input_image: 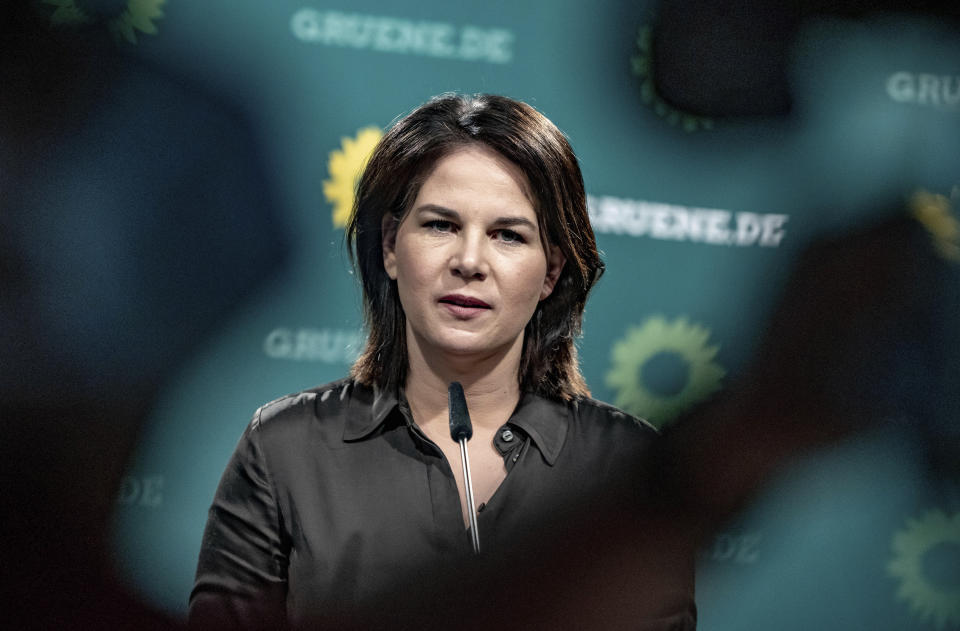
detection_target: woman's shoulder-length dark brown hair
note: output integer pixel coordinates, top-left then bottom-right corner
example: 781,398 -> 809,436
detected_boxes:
346,94 -> 603,400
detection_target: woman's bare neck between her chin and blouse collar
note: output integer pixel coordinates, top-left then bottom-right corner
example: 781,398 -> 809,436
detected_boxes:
404,329 -> 523,428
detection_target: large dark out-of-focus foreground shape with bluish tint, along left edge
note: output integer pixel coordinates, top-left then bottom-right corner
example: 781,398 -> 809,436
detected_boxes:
0,2 -> 284,629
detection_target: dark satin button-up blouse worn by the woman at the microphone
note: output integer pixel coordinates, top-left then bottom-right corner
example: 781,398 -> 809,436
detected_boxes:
190,380 -> 692,629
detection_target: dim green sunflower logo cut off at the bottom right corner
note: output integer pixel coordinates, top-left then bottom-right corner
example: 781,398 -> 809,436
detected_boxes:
887,510 -> 960,629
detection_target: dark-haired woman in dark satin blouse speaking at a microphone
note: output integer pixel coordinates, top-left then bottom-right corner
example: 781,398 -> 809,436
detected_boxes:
191,95 -> 688,627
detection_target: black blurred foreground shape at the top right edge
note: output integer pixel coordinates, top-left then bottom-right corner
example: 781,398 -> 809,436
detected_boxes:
653,0 -> 960,117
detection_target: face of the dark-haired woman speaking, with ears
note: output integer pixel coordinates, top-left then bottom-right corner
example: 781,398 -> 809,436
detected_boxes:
383,145 -> 564,368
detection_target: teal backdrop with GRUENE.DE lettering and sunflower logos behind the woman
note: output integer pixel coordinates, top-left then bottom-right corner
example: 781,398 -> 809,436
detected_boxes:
45,0 -> 960,631
